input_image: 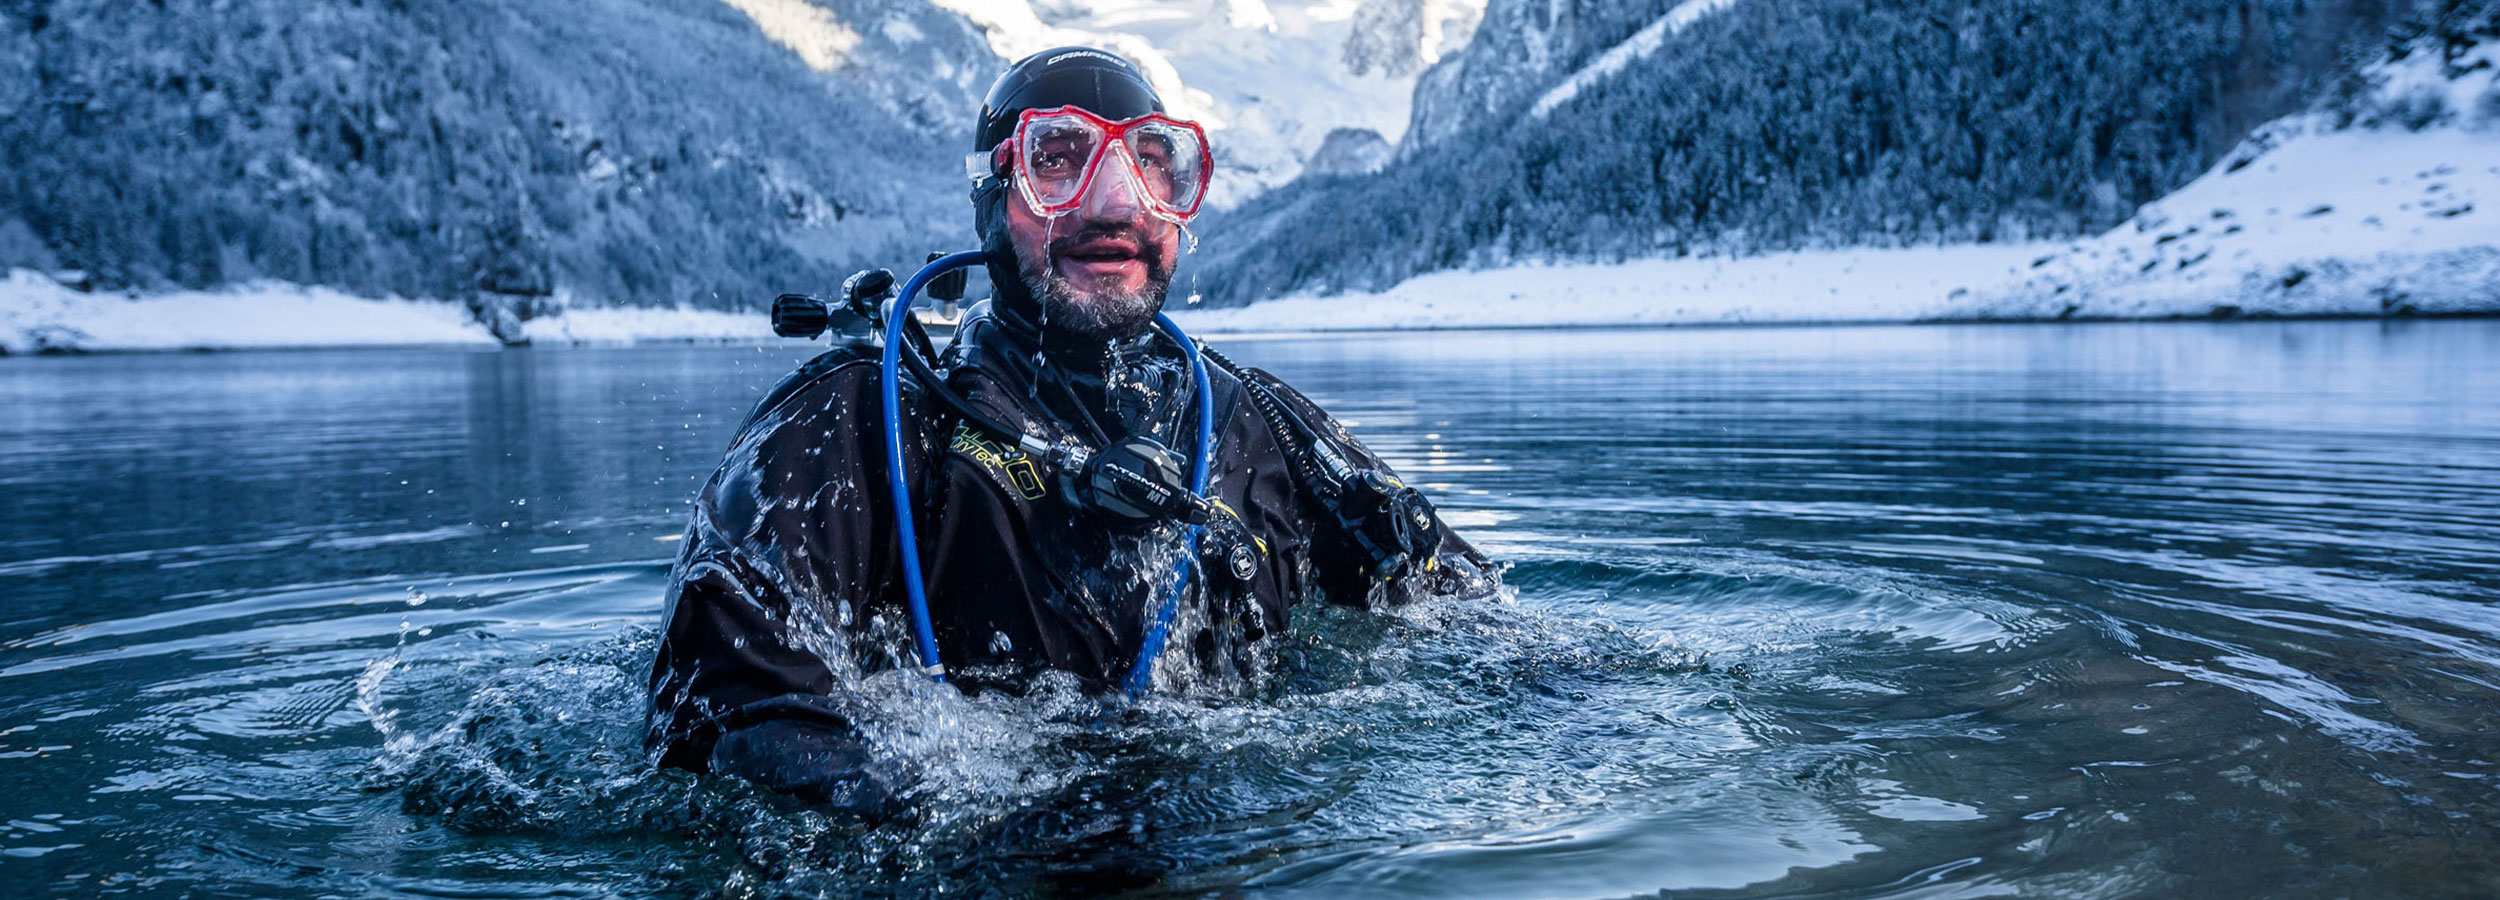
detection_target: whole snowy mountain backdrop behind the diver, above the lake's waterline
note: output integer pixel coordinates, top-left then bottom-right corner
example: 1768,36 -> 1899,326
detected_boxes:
0,0 -> 2500,350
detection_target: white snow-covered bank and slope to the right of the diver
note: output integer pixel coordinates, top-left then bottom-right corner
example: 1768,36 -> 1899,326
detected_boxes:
1175,43 -> 2500,333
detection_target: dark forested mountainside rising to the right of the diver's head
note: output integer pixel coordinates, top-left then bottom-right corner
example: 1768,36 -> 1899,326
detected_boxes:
1198,0 -> 2440,305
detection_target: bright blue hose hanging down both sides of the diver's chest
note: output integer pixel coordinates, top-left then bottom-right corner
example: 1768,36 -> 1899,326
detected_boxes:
880,250 -> 1215,695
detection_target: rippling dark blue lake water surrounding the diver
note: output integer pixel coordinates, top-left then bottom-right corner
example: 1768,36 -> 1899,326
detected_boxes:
0,320 -> 2500,898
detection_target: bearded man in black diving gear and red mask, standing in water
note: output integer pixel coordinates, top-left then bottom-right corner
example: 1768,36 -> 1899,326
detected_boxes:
648,48 -> 1498,810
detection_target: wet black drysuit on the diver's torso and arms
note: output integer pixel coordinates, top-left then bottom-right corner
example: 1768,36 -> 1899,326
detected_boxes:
648,308 -> 1493,783
